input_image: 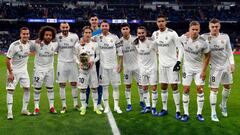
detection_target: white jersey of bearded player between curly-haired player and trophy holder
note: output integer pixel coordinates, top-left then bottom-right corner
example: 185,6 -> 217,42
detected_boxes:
56,32 -> 79,62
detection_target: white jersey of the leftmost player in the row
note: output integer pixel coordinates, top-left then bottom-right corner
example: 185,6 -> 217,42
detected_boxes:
7,40 -> 32,72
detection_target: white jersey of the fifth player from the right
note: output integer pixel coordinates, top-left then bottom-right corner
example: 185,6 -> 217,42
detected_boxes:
120,35 -> 138,70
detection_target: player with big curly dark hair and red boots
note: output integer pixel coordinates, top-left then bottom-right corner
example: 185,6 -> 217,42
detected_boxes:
31,26 -> 58,115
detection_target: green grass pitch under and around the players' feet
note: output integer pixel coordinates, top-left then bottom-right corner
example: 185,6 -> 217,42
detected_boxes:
0,55 -> 240,135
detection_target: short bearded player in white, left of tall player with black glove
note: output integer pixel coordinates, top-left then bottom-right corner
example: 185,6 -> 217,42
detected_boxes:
133,26 -> 158,116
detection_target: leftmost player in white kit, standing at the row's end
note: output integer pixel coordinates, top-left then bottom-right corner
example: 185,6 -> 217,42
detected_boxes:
6,27 -> 32,120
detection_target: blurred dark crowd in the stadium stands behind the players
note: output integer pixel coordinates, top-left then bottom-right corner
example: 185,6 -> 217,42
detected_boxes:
0,0 -> 240,51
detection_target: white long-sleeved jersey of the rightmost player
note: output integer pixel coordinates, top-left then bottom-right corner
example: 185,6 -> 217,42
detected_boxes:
202,33 -> 234,70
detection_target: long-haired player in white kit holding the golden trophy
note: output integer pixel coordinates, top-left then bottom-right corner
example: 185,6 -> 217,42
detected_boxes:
75,26 -> 102,115
